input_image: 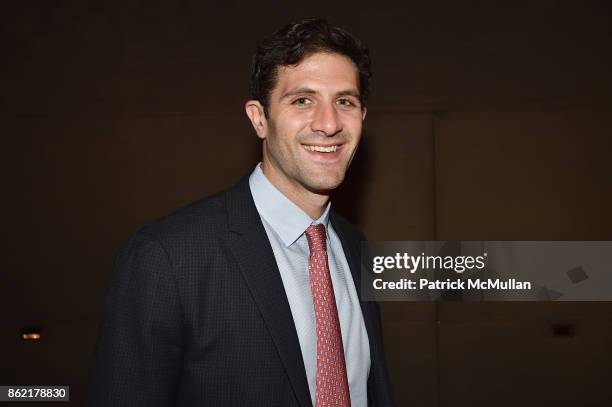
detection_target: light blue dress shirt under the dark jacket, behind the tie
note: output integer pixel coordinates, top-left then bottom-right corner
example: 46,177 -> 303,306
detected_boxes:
249,163 -> 370,407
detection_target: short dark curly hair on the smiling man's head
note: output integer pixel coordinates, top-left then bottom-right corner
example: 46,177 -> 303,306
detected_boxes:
250,18 -> 372,117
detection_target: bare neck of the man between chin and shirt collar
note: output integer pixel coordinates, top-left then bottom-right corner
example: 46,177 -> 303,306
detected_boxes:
262,165 -> 329,219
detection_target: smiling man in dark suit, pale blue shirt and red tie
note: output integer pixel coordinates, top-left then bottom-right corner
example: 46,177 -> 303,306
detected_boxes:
89,19 -> 391,407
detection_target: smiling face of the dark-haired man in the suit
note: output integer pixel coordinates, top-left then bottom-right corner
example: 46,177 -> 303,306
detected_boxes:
247,52 -> 365,198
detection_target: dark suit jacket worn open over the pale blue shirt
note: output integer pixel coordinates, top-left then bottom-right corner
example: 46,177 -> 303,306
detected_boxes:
88,177 -> 392,407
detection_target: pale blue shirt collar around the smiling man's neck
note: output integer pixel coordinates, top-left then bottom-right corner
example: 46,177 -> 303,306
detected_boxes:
249,163 -> 331,247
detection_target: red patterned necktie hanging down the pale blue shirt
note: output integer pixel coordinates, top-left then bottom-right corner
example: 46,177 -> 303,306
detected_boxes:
306,224 -> 351,407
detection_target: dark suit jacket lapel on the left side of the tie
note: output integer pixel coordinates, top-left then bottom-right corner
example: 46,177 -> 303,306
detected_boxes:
226,176 -> 312,407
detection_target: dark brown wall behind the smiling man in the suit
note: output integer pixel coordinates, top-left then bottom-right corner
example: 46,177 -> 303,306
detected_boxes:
0,0 -> 612,407
